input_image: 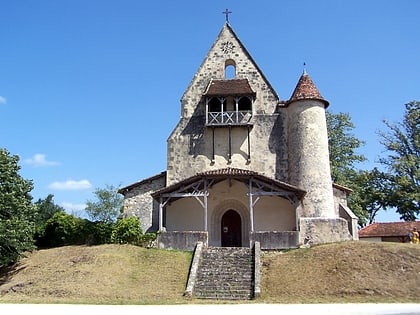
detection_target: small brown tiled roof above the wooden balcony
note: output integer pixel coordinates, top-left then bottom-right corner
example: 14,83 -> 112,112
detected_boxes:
204,79 -> 255,96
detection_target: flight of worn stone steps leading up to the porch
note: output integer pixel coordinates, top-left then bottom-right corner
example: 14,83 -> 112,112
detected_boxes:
194,247 -> 254,300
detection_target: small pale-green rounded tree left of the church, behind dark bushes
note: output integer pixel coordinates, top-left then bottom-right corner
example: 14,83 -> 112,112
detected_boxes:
85,185 -> 124,223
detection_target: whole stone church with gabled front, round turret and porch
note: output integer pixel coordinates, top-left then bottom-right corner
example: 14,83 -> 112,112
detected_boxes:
118,20 -> 358,250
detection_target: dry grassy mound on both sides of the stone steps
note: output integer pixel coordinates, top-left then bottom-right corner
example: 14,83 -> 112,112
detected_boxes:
0,242 -> 420,304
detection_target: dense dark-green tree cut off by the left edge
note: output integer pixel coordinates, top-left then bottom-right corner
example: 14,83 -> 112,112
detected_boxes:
0,149 -> 35,266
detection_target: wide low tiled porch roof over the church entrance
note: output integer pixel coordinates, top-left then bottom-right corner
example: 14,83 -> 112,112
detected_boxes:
152,167 -> 306,200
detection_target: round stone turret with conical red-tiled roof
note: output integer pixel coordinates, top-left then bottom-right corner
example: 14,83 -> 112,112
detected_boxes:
287,72 -> 335,218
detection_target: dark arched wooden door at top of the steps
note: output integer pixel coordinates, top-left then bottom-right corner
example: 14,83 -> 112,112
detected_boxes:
221,209 -> 242,247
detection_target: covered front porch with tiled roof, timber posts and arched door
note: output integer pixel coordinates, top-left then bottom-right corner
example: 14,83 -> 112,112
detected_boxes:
153,168 -> 305,250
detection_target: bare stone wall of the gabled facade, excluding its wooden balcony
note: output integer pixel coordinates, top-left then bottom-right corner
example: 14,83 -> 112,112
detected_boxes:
167,25 -> 287,185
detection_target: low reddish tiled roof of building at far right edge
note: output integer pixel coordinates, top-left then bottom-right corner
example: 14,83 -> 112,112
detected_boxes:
359,221 -> 420,238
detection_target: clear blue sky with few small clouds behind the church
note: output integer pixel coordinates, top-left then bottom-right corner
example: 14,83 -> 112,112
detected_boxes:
0,0 -> 420,222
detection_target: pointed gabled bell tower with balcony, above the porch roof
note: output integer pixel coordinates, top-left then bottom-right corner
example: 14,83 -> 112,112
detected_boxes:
167,22 -> 285,185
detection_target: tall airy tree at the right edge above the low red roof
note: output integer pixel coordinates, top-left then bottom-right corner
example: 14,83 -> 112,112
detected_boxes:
379,101 -> 420,221
